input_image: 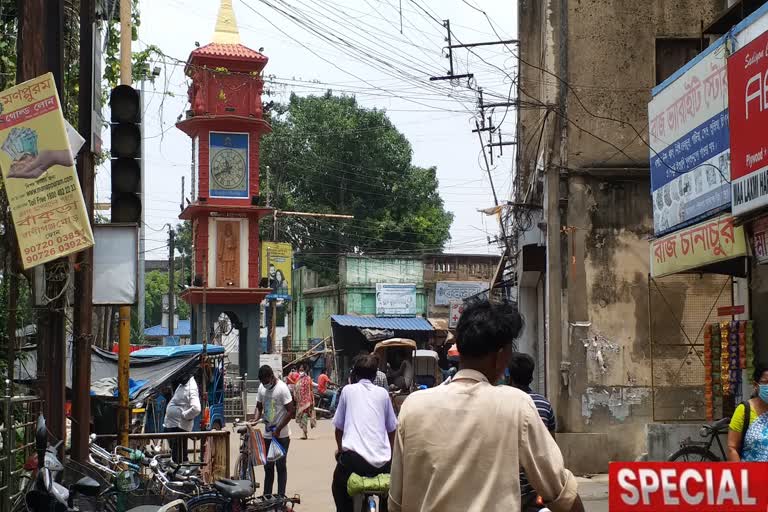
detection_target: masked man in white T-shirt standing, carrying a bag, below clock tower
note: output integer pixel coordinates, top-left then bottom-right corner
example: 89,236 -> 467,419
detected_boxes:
255,365 -> 296,496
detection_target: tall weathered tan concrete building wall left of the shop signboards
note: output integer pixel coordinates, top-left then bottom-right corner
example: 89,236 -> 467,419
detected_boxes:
516,0 -> 725,471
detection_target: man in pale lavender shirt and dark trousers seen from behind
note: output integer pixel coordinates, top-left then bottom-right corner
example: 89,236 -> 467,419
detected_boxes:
331,354 -> 397,512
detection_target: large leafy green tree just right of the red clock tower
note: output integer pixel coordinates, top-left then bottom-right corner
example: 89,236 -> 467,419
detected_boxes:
261,91 -> 453,281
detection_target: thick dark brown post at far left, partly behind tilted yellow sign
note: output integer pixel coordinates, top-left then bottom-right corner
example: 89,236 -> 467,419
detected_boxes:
14,0 -> 68,453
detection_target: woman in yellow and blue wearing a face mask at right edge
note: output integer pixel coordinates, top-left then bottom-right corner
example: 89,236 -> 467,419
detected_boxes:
728,363 -> 768,462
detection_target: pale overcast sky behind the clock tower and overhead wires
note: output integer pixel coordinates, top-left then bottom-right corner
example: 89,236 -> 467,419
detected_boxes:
97,0 -> 517,259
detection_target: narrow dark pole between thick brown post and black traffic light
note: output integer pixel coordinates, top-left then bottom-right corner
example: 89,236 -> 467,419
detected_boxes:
71,0 -> 101,464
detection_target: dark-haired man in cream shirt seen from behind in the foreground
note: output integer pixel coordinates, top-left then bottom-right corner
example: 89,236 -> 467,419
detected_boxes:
389,301 -> 584,512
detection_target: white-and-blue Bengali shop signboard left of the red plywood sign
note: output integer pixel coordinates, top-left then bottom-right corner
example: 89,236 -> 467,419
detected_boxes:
648,42 -> 731,236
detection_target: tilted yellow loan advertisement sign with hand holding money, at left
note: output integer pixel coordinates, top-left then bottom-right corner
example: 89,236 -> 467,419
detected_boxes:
0,73 -> 93,269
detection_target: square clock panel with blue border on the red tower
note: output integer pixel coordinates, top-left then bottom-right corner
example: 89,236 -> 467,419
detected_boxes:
209,132 -> 249,198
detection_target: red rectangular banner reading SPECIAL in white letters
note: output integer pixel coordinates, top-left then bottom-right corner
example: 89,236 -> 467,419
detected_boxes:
608,462 -> 768,512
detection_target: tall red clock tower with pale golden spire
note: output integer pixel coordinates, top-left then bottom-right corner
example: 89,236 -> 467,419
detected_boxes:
176,0 -> 271,375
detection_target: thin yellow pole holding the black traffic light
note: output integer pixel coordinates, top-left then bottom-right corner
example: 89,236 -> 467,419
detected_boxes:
117,0 -> 134,446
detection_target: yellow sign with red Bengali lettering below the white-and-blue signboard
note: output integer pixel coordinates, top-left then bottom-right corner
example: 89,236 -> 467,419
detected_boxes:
651,215 -> 747,277
